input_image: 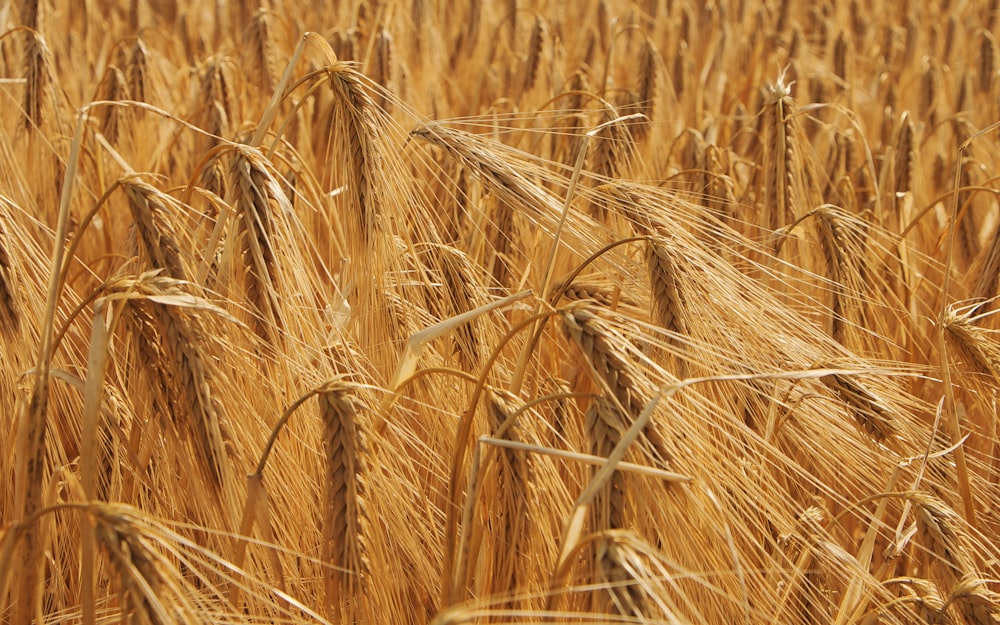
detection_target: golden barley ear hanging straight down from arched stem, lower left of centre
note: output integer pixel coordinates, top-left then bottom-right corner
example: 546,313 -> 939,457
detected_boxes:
318,380 -> 370,616
